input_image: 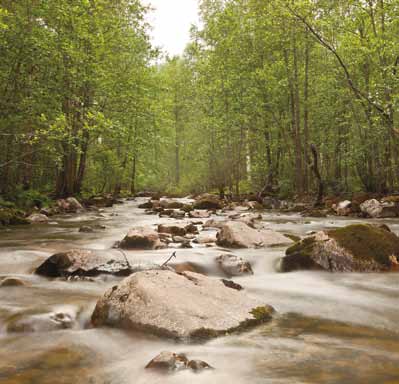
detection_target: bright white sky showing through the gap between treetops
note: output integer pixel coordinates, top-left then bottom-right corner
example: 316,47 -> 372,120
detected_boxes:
147,0 -> 198,55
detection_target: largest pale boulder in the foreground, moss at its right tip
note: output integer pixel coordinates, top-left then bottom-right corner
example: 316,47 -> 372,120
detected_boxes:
92,270 -> 274,339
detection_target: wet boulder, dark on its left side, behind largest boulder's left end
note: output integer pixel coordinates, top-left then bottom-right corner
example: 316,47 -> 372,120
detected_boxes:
35,249 -> 133,277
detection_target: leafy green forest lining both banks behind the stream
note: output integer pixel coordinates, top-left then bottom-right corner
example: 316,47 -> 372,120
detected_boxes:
0,0 -> 399,204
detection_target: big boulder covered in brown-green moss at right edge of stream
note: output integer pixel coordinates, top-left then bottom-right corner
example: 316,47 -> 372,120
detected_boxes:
281,224 -> 399,272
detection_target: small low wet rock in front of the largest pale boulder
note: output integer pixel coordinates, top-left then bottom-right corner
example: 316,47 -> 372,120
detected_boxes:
145,352 -> 212,372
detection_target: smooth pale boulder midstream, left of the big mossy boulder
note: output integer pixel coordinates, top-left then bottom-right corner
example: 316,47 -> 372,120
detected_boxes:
217,221 -> 292,248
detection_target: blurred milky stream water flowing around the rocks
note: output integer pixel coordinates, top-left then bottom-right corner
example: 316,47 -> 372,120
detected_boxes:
0,201 -> 399,384
